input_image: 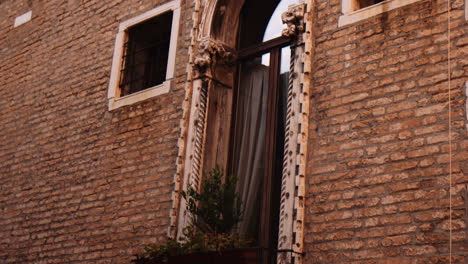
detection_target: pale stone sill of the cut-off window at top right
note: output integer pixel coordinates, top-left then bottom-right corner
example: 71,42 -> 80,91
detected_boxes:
338,0 -> 421,27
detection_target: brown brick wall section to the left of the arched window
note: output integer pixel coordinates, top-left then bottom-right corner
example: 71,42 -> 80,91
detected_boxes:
0,0 -> 191,264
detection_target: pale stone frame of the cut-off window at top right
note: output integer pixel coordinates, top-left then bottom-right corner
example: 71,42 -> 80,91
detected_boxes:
338,0 -> 421,27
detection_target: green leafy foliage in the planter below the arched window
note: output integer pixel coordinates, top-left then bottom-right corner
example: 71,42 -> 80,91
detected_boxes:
132,166 -> 250,264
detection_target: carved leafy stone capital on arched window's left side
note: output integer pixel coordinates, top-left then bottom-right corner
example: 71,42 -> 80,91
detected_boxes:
194,38 -> 235,76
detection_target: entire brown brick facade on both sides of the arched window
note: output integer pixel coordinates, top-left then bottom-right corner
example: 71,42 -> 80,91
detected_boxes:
0,0 -> 468,264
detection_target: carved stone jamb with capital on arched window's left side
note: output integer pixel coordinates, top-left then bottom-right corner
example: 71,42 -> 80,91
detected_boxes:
173,13 -> 235,237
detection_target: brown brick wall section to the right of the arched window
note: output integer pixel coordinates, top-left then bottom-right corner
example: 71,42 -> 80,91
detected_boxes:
305,0 -> 468,264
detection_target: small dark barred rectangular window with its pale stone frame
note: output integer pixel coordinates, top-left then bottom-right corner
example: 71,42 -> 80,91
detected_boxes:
108,0 -> 180,110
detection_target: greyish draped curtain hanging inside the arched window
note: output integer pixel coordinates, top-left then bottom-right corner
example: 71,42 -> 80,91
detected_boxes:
233,59 -> 268,239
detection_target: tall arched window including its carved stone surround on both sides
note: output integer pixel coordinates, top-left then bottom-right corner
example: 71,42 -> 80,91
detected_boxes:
171,0 -> 308,264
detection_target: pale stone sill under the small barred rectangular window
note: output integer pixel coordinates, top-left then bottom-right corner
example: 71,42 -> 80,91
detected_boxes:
109,80 -> 172,111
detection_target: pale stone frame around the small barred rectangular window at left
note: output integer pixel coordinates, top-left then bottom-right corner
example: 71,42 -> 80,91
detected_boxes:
107,0 -> 180,111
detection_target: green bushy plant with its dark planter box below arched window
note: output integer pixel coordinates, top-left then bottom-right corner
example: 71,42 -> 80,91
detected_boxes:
133,166 -> 261,264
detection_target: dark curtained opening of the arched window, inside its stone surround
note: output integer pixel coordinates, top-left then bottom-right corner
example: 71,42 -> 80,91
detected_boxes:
229,0 -> 297,263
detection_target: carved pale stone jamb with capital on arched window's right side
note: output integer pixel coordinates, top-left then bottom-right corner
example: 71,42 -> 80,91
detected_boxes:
277,0 -> 312,264
